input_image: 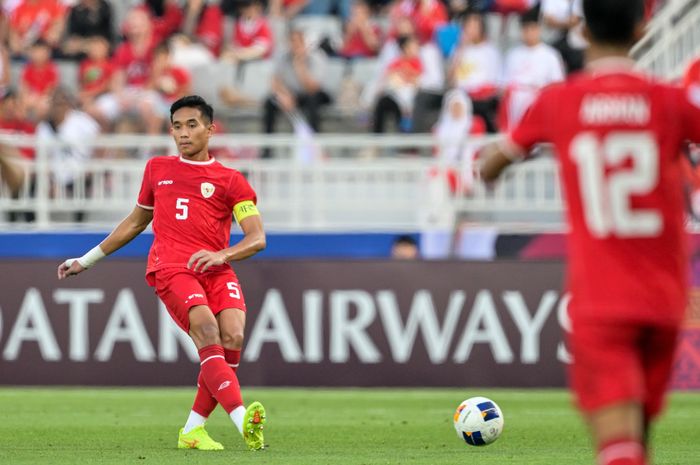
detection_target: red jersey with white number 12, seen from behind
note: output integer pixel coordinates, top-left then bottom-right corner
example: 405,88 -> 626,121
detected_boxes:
510,59 -> 700,324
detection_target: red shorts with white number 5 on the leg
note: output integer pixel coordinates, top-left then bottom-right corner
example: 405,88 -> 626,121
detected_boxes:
147,268 -> 246,334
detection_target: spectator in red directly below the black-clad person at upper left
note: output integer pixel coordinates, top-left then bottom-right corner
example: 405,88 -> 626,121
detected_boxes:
78,35 -> 114,109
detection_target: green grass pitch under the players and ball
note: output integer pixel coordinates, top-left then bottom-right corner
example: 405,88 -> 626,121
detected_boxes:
0,388 -> 700,465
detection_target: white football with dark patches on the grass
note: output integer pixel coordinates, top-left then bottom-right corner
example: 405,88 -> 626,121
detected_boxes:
454,397 -> 503,446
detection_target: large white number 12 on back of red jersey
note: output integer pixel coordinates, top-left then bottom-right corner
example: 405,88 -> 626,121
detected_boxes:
569,131 -> 663,238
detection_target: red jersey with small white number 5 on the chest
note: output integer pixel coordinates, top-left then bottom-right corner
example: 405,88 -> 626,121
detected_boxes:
138,156 -> 256,273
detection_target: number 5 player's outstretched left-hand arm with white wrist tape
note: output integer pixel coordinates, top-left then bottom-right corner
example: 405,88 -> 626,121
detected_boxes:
58,206 -> 153,279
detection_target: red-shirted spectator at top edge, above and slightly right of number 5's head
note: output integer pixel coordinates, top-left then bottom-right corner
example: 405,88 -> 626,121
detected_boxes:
221,0 -> 274,63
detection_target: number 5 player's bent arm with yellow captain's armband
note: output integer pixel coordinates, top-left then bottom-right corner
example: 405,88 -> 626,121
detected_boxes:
187,200 -> 267,272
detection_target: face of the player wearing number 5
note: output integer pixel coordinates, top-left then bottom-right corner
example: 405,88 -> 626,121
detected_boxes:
170,107 -> 214,160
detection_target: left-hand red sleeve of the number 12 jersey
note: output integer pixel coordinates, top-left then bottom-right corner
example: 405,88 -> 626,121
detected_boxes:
508,89 -> 554,158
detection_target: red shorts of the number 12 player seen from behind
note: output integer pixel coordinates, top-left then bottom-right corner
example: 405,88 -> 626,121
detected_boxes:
569,321 -> 680,418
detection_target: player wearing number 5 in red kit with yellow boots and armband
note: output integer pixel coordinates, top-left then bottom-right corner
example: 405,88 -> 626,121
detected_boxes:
58,96 -> 265,450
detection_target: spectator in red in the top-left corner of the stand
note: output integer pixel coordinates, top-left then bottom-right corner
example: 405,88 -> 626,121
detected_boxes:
9,0 -> 66,57
